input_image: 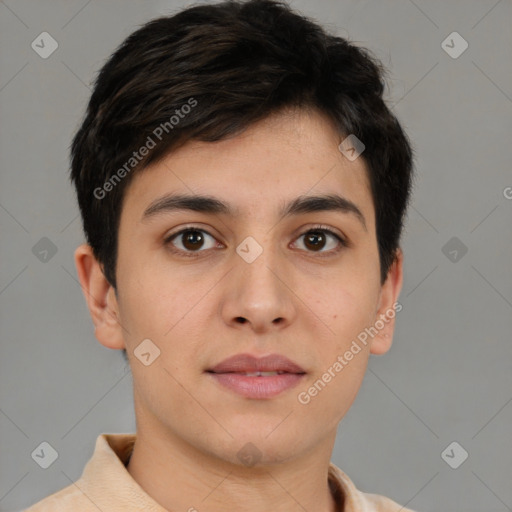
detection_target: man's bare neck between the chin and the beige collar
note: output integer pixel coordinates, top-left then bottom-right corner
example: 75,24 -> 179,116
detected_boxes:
127,429 -> 340,512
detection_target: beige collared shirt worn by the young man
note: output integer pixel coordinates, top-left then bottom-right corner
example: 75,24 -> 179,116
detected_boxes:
24,434 -> 412,512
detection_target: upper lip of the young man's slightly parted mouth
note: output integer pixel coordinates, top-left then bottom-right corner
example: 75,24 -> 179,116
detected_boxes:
207,354 -> 306,373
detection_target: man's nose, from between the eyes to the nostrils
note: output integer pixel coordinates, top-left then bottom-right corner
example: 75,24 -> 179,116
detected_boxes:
221,242 -> 297,334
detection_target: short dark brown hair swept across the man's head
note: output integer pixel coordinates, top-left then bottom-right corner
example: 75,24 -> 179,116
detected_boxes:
71,0 -> 413,308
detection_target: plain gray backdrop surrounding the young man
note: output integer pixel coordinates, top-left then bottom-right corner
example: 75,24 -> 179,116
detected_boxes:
0,0 -> 512,512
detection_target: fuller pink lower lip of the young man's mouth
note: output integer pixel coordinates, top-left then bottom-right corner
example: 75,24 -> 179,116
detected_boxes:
210,372 -> 304,399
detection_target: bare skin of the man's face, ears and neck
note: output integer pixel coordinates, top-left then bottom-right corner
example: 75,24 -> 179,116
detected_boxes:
75,106 -> 403,512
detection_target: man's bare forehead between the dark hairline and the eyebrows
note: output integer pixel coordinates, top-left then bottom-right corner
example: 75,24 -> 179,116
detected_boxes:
123,111 -> 374,228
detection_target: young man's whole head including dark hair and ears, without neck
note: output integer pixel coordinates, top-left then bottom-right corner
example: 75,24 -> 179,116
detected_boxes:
71,0 -> 412,462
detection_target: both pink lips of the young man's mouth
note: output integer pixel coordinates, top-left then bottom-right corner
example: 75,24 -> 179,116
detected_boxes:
207,354 -> 306,400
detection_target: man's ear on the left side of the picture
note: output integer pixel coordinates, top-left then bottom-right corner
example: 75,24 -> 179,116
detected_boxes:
75,244 -> 125,349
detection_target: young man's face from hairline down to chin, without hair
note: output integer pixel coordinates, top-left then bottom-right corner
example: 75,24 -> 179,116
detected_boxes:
77,111 -> 401,463
